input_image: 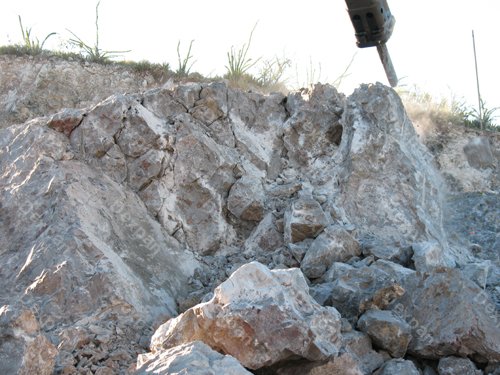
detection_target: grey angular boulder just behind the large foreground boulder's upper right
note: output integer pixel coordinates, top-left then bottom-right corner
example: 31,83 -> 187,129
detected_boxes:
300,225 -> 361,279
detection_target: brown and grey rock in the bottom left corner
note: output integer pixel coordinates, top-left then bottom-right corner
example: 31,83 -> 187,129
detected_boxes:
0,305 -> 58,375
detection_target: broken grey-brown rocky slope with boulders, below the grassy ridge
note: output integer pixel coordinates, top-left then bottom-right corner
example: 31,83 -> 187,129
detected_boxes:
0,53 -> 500,375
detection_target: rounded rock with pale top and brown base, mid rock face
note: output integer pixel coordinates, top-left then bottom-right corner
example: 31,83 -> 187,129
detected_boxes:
227,176 -> 265,221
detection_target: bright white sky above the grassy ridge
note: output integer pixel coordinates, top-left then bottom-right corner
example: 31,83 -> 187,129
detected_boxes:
0,0 -> 500,114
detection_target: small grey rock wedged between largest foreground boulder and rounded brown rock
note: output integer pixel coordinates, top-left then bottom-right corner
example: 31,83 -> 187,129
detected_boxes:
342,331 -> 384,374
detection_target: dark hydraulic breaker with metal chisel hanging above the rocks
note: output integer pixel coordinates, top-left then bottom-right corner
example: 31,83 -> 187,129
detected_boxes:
346,0 -> 398,87
